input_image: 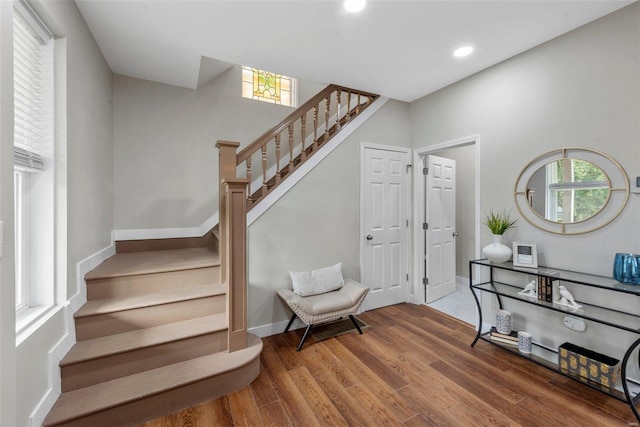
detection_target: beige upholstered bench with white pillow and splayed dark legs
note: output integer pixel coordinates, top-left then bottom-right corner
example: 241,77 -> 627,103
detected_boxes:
276,263 -> 369,351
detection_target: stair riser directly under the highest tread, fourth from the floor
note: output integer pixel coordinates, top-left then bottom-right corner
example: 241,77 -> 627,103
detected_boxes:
87,267 -> 220,300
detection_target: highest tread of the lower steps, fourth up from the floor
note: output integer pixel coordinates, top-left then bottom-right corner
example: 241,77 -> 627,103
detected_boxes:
85,247 -> 220,280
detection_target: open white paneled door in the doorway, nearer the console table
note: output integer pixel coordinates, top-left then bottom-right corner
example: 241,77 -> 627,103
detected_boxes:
424,155 -> 456,303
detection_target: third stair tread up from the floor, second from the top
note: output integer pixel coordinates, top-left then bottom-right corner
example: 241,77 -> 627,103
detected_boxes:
74,284 -> 227,319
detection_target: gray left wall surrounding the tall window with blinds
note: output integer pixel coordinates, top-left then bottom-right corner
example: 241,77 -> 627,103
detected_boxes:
7,1 -> 114,426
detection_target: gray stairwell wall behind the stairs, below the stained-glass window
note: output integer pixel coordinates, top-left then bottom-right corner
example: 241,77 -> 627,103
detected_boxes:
113,66 -> 326,230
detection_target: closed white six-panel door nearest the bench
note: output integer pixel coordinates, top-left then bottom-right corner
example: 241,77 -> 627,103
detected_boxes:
360,146 -> 409,310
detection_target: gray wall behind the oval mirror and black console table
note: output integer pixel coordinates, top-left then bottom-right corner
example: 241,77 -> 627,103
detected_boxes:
410,2 -> 640,366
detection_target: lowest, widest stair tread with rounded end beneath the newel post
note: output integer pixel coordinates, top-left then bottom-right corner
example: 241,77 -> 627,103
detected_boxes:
44,334 -> 262,426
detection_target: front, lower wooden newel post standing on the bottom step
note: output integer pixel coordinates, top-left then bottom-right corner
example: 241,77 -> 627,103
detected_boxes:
220,178 -> 249,352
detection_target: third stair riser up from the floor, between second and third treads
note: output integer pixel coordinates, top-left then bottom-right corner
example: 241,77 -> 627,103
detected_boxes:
75,295 -> 226,341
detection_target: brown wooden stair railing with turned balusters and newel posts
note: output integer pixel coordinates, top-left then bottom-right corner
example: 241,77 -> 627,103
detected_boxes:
216,85 -> 378,352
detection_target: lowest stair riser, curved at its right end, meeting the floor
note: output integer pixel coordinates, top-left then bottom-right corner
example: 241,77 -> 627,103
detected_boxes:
45,357 -> 260,427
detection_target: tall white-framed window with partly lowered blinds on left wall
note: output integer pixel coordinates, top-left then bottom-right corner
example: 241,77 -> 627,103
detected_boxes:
13,0 -> 57,320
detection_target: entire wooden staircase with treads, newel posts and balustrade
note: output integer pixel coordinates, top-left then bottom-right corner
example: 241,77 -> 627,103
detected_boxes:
43,85 -> 378,427
